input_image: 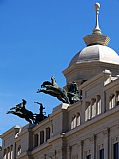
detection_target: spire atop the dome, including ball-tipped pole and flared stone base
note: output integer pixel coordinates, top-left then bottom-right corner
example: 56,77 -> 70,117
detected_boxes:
84,3 -> 110,46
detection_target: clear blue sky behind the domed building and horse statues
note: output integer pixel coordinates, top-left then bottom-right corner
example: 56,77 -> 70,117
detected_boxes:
0,0 -> 119,142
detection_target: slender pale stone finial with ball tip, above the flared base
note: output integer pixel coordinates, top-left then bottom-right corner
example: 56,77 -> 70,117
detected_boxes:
93,3 -> 101,34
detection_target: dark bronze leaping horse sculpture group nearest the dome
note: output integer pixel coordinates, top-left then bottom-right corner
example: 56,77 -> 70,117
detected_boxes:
37,76 -> 80,104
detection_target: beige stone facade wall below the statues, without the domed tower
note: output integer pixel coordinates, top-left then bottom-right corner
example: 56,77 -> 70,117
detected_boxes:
2,73 -> 119,159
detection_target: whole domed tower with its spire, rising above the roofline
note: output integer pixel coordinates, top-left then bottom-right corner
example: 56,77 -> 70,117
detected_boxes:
63,3 -> 119,83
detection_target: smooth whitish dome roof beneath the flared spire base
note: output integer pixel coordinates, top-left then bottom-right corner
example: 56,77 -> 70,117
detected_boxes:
69,45 -> 119,66
